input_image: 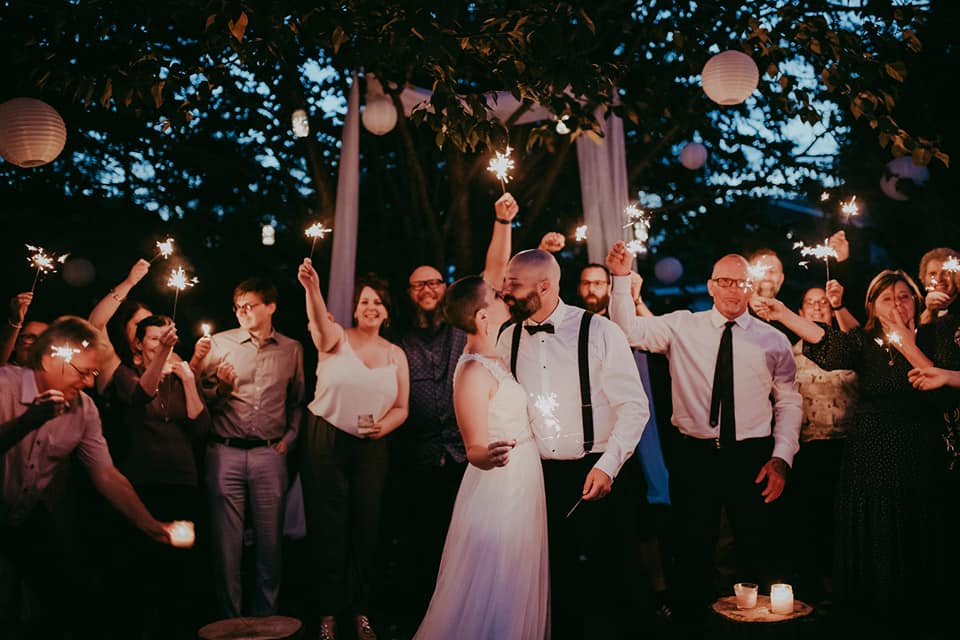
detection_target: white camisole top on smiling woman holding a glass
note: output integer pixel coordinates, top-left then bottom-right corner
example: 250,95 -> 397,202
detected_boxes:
307,336 -> 398,436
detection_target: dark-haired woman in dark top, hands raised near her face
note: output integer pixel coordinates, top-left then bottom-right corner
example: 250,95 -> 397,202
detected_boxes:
113,316 -> 210,638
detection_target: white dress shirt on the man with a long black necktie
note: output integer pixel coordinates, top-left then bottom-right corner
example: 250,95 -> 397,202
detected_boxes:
610,276 -> 803,465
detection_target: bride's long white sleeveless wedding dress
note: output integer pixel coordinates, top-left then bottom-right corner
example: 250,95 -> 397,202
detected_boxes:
414,354 -> 550,640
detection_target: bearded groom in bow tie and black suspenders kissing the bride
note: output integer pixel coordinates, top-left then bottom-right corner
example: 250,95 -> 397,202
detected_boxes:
498,249 -> 649,639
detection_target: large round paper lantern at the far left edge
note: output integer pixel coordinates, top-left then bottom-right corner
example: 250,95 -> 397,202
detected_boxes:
0,98 -> 67,168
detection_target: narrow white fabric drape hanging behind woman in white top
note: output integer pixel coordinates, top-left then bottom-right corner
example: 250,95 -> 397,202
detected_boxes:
327,73 -> 360,327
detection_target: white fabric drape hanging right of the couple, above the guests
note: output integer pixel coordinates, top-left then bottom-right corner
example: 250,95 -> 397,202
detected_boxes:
577,109 -> 630,264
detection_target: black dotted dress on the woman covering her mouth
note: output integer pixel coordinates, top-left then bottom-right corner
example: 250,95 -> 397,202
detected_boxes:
804,325 -> 949,614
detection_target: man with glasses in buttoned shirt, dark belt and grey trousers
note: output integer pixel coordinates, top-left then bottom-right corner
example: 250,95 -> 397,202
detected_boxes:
200,278 -> 304,618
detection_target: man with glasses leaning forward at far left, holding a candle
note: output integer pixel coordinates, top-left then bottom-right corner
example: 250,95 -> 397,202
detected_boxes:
0,316 -> 169,638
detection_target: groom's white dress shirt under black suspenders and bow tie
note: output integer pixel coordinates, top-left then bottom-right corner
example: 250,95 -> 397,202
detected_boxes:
497,301 -> 650,478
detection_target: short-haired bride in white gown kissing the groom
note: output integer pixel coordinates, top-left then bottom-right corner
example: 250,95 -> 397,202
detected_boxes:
414,276 -> 550,640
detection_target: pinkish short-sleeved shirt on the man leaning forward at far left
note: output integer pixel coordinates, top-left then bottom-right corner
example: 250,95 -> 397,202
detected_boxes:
0,367 -> 113,525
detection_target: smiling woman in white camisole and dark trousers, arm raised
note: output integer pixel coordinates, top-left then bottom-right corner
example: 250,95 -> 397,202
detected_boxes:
297,259 -> 410,640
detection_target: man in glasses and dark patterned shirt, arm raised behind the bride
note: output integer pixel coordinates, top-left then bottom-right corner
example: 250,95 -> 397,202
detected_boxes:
385,193 -> 519,628
